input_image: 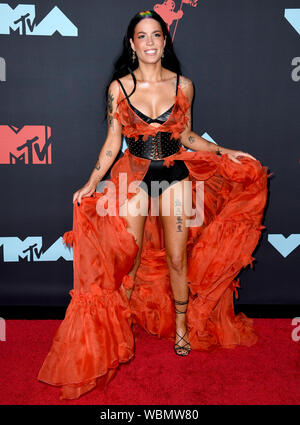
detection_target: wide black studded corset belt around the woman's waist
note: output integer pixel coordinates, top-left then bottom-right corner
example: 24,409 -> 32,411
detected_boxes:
125,131 -> 181,159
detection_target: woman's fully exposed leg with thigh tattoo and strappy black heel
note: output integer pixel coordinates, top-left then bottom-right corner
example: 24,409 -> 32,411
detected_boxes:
159,177 -> 192,355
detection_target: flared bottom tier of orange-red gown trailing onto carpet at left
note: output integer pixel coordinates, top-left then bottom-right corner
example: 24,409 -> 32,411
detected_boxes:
38,283 -> 134,399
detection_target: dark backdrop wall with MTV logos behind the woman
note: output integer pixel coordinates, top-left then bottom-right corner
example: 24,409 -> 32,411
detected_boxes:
0,0 -> 300,312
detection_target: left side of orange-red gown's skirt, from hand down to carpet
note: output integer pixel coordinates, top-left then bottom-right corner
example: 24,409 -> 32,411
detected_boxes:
38,193 -> 138,399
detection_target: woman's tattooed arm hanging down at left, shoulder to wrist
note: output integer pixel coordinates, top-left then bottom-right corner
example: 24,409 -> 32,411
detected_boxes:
89,80 -> 122,183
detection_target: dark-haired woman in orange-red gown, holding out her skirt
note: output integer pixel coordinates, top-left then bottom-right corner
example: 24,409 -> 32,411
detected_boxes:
38,11 -> 268,399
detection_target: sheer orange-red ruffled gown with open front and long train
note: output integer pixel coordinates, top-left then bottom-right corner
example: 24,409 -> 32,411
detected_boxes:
38,82 -> 271,400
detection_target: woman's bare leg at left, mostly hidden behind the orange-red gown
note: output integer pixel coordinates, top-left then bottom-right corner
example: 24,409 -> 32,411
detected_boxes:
119,189 -> 149,300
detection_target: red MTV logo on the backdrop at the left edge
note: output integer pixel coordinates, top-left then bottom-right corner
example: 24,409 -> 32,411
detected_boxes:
0,125 -> 52,165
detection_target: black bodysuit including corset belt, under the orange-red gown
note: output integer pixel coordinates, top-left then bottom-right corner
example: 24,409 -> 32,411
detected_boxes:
118,74 -> 189,197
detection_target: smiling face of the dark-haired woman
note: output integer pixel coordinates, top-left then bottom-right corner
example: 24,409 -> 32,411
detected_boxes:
130,18 -> 166,63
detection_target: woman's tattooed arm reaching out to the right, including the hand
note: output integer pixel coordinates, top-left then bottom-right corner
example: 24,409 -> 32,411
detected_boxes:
180,77 -> 256,164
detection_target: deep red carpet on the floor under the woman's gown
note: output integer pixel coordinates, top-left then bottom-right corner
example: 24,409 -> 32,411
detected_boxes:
0,319 -> 300,405
